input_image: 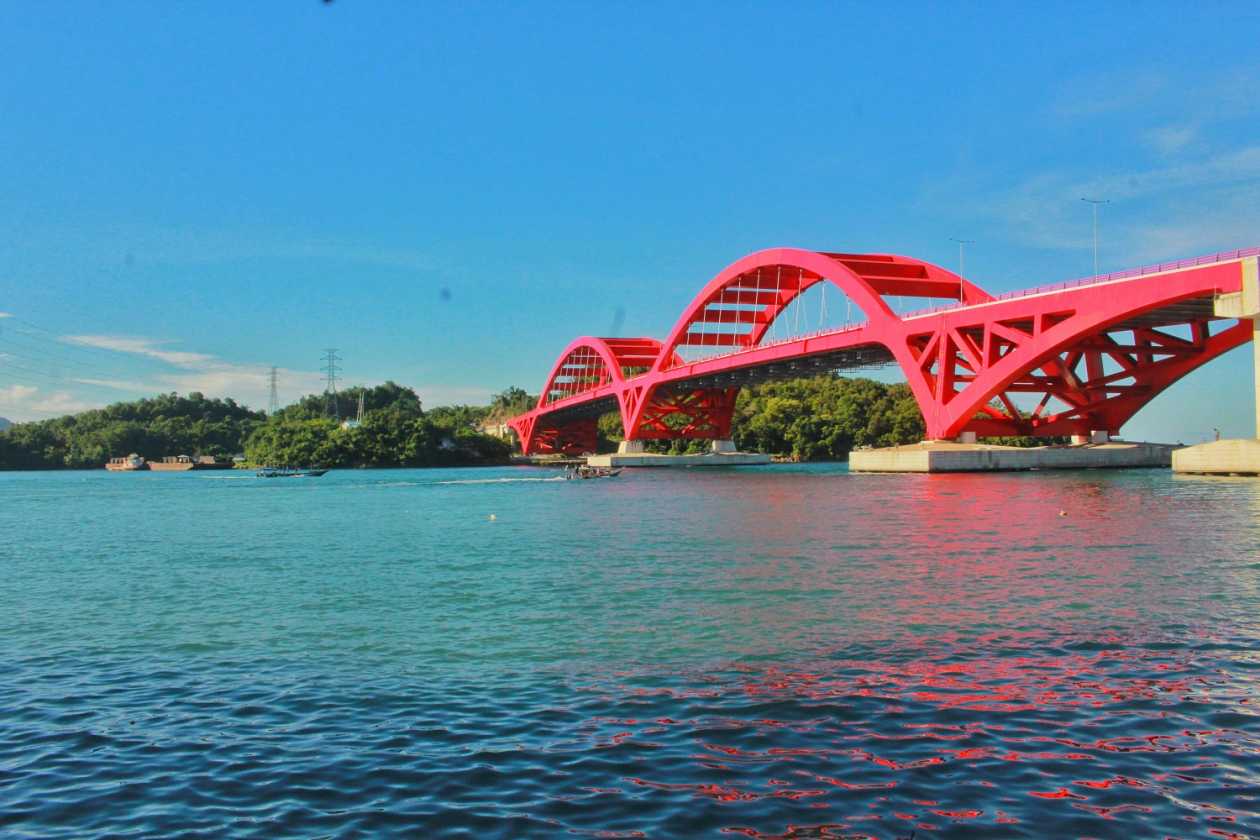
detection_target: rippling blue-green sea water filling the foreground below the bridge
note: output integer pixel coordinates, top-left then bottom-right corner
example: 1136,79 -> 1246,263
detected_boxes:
0,466 -> 1260,837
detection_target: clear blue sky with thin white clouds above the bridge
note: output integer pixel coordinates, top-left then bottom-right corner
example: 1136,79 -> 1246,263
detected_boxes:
0,0 -> 1260,441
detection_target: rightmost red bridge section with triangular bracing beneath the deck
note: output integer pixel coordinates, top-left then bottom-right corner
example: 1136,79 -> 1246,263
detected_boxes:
902,256 -> 1255,438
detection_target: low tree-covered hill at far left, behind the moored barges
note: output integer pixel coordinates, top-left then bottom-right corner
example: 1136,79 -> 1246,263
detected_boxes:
0,392 -> 266,470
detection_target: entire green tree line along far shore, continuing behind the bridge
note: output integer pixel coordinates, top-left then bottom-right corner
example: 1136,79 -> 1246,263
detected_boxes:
0,374 -> 972,470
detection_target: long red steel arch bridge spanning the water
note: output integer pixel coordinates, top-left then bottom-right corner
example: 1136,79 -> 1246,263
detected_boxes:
509,248 -> 1260,455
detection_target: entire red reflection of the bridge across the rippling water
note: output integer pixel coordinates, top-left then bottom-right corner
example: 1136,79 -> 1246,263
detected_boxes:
574,475 -> 1260,837
